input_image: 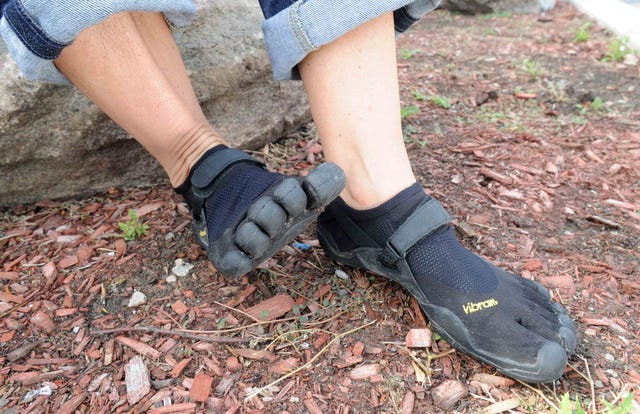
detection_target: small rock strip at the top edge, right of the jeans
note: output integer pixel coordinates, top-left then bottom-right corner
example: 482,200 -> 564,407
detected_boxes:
440,0 -> 556,14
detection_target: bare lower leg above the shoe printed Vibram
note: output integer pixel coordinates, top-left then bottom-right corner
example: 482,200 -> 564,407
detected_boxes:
300,14 -> 416,209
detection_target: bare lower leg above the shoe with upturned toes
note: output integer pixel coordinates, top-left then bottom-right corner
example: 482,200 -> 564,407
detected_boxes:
55,12 -> 223,186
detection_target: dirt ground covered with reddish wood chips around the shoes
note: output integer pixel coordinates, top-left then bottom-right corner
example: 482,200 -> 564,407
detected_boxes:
0,2 -> 640,414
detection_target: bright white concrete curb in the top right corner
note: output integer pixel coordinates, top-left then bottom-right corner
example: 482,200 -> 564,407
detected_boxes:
570,0 -> 640,49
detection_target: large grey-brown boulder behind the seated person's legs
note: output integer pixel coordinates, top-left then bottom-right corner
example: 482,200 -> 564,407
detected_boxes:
0,0 -> 311,206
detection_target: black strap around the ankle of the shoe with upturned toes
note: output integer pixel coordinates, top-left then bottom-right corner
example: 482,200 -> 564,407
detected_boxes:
191,148 -> 264,218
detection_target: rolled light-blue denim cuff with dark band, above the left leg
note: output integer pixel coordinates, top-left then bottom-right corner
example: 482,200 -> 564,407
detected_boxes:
0,0 -> 196,84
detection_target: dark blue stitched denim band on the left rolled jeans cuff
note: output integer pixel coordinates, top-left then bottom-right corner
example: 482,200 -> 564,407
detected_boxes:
4,0 -> 70,60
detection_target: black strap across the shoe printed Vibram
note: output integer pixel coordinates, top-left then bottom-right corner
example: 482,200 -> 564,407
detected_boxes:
380,198 -> 451,264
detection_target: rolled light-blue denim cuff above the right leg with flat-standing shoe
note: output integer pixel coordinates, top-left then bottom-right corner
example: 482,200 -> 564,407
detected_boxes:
262,0 -> 440,80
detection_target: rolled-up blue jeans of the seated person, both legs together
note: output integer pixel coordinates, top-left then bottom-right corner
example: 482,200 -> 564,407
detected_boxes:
0,0 -> 440,83
